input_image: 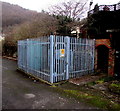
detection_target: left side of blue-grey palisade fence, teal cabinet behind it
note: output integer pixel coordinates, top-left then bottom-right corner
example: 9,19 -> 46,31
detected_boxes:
18,37 -> 50,82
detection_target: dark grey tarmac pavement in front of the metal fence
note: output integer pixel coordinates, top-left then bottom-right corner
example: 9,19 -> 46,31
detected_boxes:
0,58 -> 97,109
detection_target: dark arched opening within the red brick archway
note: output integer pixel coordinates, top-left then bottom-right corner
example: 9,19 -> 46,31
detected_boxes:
97,45 -> 109,73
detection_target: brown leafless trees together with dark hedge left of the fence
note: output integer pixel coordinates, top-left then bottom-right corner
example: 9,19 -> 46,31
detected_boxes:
3,13 -> 57,56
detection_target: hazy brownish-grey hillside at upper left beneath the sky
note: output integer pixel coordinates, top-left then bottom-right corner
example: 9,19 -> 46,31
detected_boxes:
2,2 -> 38,28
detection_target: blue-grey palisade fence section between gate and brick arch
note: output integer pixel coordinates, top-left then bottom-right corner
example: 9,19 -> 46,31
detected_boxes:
69,38 -> 94,78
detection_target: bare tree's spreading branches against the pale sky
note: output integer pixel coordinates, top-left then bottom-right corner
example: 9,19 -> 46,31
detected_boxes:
49,0 -> 88,20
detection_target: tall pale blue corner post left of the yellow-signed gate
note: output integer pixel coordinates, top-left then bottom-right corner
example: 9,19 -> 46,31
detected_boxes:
50,35 -> 54,83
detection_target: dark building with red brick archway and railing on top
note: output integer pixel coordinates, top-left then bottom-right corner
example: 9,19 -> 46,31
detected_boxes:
87,3 -> 120,76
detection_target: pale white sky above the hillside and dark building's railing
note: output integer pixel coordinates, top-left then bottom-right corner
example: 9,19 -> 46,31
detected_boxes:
1,0 -> 120,12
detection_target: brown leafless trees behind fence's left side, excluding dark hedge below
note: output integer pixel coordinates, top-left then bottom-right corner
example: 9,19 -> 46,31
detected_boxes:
6,13 -> 57,43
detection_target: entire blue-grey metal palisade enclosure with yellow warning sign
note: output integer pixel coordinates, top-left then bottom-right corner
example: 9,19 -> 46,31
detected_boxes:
18,36 -> 95,83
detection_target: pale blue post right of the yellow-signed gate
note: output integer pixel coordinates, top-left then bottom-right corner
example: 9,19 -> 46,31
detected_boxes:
66,37 -> 70,80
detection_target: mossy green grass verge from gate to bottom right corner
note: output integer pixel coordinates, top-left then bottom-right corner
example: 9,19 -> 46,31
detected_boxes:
52,83 -> 120,111
